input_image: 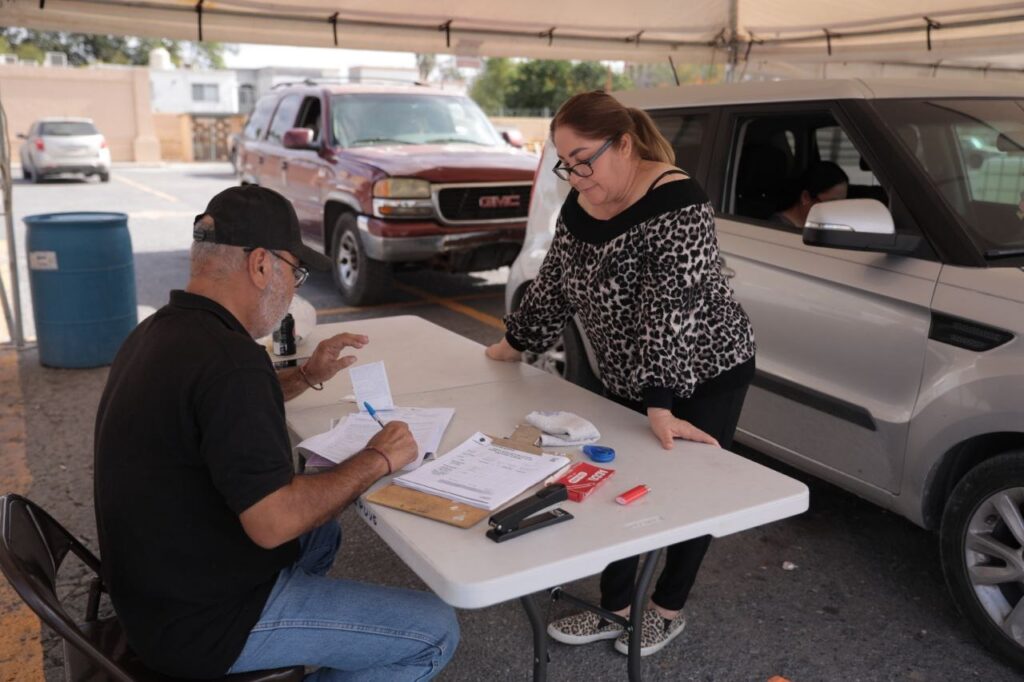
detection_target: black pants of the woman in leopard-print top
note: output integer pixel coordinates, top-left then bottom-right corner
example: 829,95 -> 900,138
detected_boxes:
601,360 -> 754,611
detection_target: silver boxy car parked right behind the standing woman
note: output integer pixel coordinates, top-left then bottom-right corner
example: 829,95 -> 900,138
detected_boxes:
506,80 -> 1024,666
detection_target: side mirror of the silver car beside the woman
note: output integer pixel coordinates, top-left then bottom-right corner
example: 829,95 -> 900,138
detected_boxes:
804,199 -> 921,254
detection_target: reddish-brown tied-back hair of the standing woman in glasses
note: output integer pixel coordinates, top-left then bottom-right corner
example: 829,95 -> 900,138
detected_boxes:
551,90 -> 676,164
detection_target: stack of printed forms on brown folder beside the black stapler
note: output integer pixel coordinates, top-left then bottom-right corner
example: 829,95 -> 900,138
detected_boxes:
394,433 -> 569,510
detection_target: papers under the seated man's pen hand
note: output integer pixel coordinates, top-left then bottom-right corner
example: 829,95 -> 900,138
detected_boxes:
297,408 -> 455,471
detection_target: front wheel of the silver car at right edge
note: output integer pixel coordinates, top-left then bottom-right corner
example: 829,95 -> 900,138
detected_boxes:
941,452 -> 1024,667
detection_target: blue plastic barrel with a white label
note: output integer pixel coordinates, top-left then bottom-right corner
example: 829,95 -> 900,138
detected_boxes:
25,211 -> 138,368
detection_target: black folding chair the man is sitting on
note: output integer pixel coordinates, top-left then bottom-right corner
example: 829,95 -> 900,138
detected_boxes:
0,494 -> 304,682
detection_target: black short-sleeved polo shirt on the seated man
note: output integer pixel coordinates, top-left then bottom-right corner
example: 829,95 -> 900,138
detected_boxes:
94,291 -> 299,678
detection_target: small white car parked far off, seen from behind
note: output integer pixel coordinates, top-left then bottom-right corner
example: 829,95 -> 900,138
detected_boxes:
17,118 -> 111,182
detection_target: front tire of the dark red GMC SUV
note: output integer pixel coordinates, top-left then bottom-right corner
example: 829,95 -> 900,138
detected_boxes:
331,213 -> 391,305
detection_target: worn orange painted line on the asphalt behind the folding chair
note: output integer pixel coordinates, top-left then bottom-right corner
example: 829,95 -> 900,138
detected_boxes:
0,350 -> 44,682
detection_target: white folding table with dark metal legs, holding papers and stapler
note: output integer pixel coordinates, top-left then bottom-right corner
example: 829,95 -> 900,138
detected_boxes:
288,316 -> 808,680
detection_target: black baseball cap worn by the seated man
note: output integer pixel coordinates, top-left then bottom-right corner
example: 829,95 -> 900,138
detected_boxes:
193,184 -> 332,270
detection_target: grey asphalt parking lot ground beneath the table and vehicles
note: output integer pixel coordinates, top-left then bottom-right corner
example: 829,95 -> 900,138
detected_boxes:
0,164 -> 1019,682
